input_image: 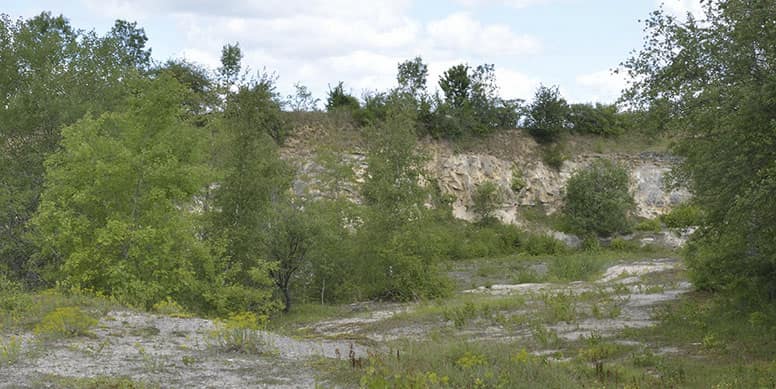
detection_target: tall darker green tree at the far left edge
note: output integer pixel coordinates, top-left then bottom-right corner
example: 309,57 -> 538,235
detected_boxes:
0,13 -> 138,282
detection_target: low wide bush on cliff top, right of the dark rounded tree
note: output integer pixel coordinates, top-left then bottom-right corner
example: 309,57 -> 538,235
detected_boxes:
568,103 -> 625,136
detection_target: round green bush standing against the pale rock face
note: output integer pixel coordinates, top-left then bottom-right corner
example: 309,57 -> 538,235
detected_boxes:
563,160 -> 635,235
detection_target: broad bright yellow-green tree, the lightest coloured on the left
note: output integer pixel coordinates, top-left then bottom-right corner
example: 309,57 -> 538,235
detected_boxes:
32,76 -> 210,308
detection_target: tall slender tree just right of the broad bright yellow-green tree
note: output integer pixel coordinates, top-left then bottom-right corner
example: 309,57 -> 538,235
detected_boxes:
209,82 -> 291,305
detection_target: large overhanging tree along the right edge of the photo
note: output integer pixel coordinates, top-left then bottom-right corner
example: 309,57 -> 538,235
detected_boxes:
624,0 -> 776,303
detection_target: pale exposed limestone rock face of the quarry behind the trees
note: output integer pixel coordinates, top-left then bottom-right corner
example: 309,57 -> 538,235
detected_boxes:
282,131 -> 690,225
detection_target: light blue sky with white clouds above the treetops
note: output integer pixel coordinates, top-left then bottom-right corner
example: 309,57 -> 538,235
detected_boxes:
0,0 -> 701,103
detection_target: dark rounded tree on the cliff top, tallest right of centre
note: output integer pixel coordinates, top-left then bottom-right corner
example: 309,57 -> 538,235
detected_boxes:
525,85 -> 569,143
